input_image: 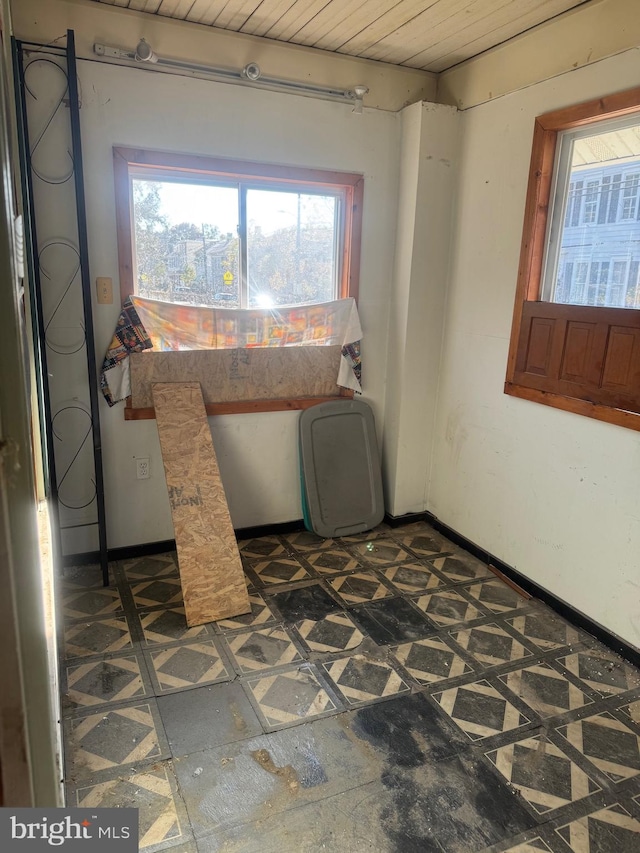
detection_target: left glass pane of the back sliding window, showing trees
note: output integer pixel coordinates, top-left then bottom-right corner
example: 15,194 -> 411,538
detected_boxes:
133,178 -> 240,308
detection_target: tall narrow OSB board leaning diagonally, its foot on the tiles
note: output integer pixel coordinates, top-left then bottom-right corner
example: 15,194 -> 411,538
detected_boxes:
153,382 -> 251,627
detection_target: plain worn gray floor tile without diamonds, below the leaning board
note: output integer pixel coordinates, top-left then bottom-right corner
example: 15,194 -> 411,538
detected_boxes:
158,682 -> 262,757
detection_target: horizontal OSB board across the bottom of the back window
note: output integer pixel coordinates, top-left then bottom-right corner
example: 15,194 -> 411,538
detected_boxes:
130,346 -> 341,409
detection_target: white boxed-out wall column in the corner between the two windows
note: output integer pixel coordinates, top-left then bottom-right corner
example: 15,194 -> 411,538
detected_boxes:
384,103 -> 459,516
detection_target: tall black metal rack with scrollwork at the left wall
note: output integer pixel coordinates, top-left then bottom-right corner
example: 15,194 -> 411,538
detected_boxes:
13,30 -> 109,586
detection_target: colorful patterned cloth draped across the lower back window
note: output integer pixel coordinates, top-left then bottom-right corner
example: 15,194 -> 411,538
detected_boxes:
101,296 -> 362,406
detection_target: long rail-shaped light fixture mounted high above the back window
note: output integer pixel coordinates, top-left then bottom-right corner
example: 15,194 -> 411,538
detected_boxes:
93,39 -> 369,114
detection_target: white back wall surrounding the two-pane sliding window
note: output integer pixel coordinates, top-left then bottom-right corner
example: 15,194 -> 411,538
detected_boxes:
76,61 -> 400,550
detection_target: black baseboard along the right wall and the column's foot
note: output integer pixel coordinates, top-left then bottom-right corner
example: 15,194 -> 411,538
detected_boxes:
385,513 -> 640,667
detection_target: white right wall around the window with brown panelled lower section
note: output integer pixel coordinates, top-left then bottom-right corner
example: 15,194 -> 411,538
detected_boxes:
428,50 -> 640,645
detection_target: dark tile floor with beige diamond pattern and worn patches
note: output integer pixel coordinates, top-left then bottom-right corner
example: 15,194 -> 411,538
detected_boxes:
59,524 -> 640,853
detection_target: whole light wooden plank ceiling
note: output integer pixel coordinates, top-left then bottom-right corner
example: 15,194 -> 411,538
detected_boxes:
89,0 -> 597,72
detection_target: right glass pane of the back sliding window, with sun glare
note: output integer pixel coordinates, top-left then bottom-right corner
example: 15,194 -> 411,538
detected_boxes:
247,189 -> 339,308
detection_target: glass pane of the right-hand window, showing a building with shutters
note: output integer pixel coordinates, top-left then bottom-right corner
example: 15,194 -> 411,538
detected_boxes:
544,118 -> 640,308
